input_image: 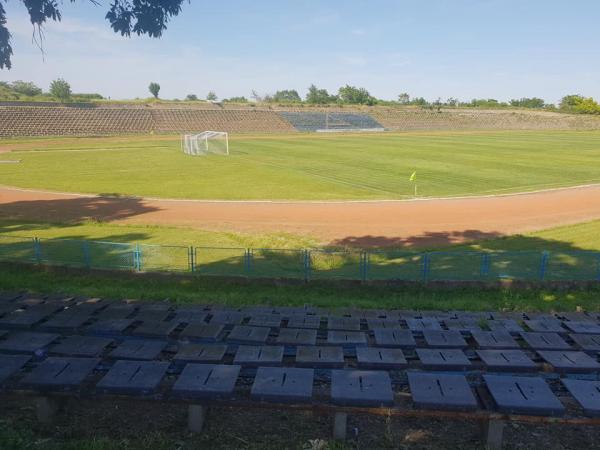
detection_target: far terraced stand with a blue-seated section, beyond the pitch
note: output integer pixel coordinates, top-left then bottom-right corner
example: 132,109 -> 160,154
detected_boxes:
0,102 -> 600,137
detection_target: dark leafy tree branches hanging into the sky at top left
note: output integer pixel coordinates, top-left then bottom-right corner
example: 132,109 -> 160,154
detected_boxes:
0,0 -> 185,69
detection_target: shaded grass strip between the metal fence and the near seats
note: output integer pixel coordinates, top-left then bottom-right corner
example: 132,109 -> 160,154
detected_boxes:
0,264 -> 600,311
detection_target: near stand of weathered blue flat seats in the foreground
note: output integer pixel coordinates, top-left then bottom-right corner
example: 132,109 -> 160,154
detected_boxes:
0,293 -> 600,448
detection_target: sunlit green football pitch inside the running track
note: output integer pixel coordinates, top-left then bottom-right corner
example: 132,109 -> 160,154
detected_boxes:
0,131 -> 600,200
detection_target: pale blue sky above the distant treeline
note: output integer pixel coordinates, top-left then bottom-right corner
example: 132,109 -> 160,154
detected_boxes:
0,0 -> 600,102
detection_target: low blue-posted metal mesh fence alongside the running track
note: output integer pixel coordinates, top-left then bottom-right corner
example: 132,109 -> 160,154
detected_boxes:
0,235 -> 600,282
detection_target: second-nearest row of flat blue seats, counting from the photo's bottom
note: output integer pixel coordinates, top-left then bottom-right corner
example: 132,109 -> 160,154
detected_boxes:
0,329 -> 600,374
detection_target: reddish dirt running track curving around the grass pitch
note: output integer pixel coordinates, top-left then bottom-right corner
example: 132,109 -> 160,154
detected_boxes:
0,185 -> 600,246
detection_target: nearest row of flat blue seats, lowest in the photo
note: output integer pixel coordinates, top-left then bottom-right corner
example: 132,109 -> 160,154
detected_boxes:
0,355 -> 600,416
